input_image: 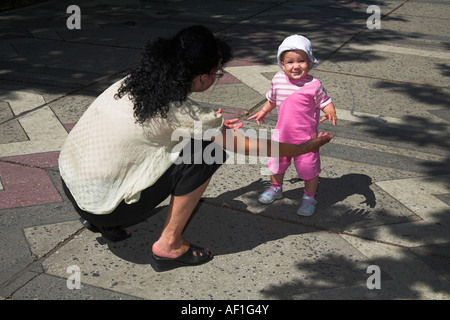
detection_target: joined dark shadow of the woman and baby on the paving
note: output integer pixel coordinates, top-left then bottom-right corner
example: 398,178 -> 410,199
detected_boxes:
105,174 -> 376,264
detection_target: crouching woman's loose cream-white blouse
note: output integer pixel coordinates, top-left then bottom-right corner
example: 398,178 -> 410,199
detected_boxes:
59,80 -> 223,214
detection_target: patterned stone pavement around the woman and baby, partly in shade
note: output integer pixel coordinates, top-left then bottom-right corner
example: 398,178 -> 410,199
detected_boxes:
0,0 -> 450,302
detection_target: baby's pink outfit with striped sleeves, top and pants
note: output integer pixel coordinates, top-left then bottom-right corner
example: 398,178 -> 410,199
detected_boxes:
266,72 -> 331,180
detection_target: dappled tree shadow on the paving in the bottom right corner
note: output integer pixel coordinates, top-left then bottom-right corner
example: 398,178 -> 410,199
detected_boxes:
262,243 -> 450,300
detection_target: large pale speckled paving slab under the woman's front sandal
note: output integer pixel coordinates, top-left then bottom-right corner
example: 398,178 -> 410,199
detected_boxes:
25,204 -> 386,299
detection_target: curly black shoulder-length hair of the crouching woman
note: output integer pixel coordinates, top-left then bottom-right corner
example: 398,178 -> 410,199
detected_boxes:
115,26 -> 232,124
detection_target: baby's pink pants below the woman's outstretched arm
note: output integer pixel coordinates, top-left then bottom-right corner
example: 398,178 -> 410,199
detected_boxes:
267,152 -> 320,180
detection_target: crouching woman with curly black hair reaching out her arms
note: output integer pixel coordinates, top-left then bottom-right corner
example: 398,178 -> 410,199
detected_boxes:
59,26 -> 332,271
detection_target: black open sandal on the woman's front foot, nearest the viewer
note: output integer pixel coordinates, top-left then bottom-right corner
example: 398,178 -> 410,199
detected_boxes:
150,244 -> 213,272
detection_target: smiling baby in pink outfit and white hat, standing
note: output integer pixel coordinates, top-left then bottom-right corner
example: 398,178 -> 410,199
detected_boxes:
248,35 -> 337,216
